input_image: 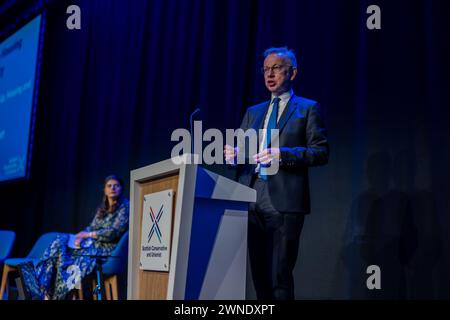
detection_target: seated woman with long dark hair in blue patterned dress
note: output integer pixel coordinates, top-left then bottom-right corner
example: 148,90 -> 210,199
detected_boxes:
19,175 -> 129,300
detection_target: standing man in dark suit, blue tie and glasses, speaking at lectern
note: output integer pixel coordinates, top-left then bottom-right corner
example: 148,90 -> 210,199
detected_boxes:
224,47 -> 329,299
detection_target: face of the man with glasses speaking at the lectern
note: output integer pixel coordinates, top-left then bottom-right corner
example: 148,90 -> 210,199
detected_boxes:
263,53 -> 297,96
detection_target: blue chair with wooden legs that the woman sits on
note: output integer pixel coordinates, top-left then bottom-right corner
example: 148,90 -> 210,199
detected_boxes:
93,231 -> 128,300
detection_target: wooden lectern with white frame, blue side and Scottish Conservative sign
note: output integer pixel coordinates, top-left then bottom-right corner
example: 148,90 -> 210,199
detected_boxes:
127,155 -> 256,300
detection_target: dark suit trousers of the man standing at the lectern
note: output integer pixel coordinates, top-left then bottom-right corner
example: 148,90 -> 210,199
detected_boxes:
248,177 -> 304,300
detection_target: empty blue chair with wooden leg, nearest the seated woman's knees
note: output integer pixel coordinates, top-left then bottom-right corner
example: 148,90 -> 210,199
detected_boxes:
0,232 -> 59,300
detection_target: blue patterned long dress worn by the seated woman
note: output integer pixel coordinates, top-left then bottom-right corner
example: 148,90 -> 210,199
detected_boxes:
36,198 -> 129,300
